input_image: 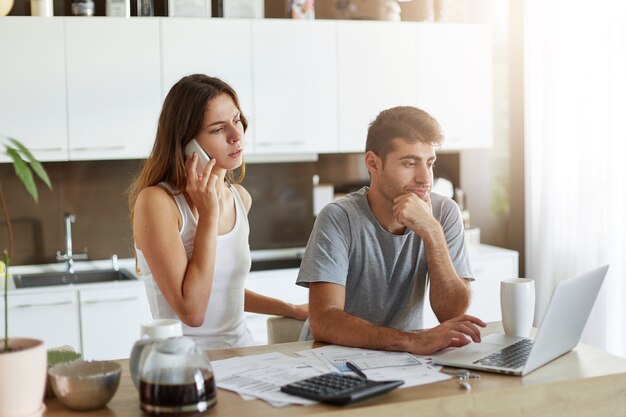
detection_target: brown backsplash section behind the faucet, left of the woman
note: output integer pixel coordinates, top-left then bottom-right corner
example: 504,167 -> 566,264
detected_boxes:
0,160 -> 139,265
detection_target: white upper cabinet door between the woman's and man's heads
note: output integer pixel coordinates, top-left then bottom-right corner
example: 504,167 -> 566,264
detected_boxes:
252,20 -> 338,154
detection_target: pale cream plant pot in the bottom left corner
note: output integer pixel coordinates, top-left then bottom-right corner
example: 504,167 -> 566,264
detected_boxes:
0,338 -> 48,417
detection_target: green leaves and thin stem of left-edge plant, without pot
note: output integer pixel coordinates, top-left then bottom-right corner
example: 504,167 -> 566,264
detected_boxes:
0,136 -> 52,353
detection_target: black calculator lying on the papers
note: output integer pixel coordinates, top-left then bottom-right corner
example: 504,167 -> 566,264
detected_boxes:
280,372 -> 404,405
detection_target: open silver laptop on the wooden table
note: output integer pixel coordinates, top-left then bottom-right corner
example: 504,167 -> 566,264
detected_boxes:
433,265 -> 609,376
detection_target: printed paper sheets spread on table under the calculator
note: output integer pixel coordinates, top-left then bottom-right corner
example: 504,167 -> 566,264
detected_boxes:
212,345 -> 450,407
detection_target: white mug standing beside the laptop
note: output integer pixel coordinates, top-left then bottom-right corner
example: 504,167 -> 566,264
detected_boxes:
500,278 -> 535,337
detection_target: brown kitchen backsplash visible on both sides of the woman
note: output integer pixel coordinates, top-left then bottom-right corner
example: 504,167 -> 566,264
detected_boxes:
0,160 -> 314,265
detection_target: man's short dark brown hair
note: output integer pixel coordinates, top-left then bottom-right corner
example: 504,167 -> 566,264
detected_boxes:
365,106 -> 443,161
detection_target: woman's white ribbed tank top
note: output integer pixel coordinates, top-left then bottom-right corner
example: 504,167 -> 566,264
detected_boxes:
135,183 -> 254,349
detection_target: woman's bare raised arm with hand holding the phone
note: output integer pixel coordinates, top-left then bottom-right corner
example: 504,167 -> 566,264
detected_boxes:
133,158 -> 219,327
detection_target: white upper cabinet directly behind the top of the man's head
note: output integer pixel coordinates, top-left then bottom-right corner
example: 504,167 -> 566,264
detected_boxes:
338,22 -> 493,152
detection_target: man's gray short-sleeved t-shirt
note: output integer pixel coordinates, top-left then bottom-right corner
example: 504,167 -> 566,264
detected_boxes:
296,187 -> 472,330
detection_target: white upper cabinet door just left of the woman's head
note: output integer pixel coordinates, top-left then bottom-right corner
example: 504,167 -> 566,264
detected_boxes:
65,17 -> 161,160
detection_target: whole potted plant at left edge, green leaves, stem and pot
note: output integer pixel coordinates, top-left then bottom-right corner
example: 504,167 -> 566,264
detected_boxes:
0,136 -> 52,417
